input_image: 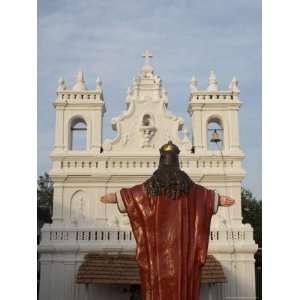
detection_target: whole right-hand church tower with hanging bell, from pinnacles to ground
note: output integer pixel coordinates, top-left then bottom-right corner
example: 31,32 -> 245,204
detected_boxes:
188,71 -> 257,299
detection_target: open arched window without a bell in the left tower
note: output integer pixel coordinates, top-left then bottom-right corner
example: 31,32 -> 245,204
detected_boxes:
69,118 -> 87,151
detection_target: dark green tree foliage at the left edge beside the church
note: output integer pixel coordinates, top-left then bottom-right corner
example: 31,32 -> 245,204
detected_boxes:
37,173 -> 53,223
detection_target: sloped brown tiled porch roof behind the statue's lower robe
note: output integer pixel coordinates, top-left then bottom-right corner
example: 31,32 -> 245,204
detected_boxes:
76,254 -> 226,284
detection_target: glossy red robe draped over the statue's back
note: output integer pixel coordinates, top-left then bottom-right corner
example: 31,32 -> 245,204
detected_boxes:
121,184 -> 214,300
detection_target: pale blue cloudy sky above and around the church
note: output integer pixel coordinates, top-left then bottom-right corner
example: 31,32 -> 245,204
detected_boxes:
37,0 -> 261,198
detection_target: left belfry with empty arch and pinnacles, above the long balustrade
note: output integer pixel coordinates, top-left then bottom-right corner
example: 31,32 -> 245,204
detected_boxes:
52,71 -> 105,155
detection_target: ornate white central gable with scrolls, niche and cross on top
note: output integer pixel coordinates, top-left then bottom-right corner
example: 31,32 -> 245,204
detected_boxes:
103,51 -> 192,154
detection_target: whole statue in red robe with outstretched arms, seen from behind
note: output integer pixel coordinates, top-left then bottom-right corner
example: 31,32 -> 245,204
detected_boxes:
101,141 -> 235,300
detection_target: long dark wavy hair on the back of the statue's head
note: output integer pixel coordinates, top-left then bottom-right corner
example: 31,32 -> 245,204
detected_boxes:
144,151 -> 193,199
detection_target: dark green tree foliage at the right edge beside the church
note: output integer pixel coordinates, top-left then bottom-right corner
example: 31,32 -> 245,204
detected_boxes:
241,188 -> 262,248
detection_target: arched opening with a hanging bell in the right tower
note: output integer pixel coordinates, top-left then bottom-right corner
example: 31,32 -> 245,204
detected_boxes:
207,117 -> 224,150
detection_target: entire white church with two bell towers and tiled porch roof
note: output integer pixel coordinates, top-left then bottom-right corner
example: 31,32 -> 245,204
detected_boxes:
39,51 -> 257,300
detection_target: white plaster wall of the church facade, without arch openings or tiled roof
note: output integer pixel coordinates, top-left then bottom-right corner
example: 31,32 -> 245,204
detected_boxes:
39,66 -> 256,300
